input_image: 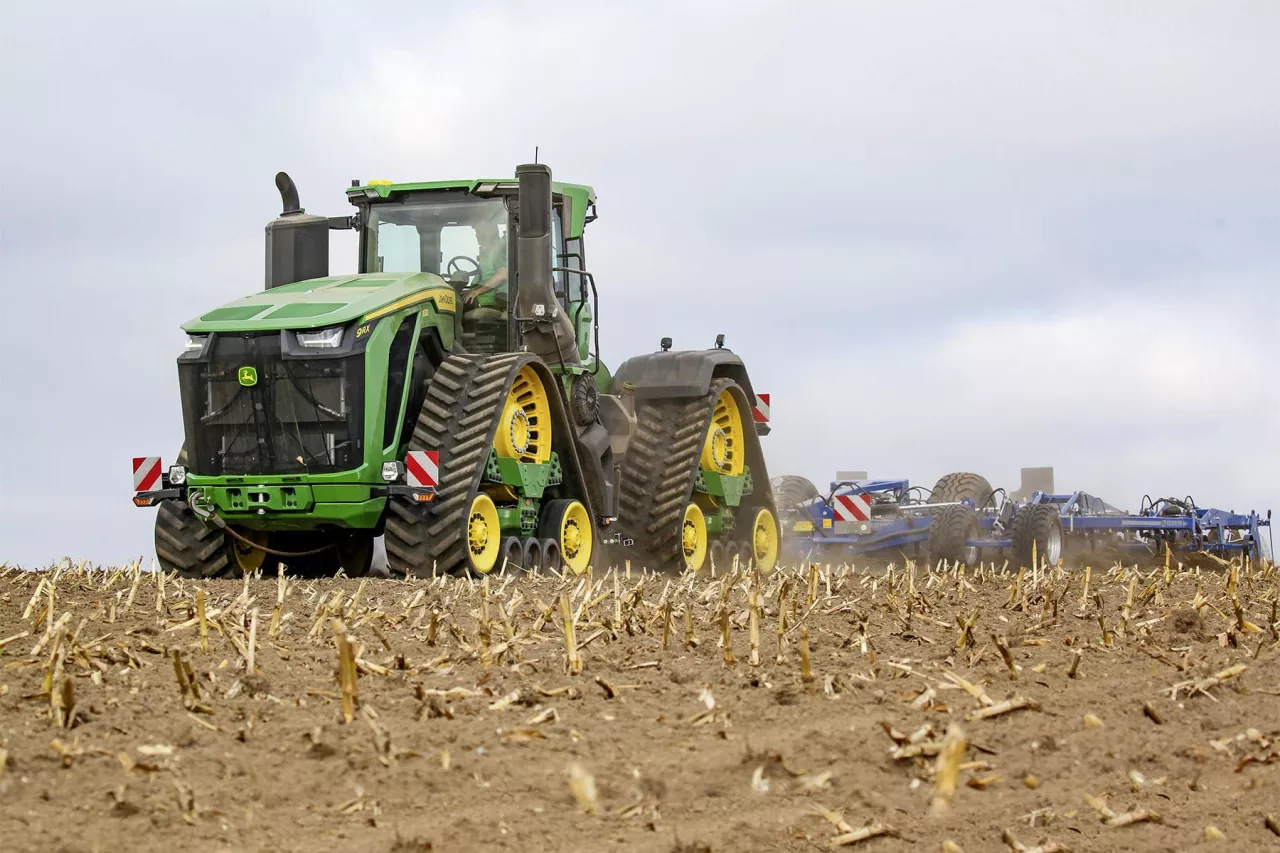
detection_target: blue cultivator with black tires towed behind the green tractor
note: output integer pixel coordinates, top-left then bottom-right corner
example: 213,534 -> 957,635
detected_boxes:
778,469 -> 1275,565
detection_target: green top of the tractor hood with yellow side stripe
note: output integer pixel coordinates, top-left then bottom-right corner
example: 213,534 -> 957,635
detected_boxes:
182,273 -> 457,334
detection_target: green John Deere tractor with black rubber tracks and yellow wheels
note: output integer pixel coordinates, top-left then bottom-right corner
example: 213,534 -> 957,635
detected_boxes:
133,164 -> 778,578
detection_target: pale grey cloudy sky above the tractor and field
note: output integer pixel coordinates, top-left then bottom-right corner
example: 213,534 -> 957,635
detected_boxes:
0,0 -> 1280,566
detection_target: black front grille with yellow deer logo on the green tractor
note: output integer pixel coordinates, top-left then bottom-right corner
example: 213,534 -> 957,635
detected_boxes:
178,332 -> 365,476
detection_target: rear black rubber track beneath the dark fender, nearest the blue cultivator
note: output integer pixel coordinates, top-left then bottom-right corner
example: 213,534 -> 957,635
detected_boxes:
618,379 -> 773,570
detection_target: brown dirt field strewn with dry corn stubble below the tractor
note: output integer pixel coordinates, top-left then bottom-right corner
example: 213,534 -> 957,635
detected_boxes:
0,565 -> 1280,853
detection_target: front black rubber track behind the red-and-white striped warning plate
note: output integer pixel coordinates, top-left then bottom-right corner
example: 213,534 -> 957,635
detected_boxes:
384,352 -> 593,576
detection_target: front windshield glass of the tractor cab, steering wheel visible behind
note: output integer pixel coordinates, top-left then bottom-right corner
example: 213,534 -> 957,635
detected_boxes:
365,192 -> 507,280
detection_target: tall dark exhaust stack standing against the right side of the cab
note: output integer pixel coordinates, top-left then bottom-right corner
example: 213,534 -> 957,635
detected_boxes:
516,163 -> 581,365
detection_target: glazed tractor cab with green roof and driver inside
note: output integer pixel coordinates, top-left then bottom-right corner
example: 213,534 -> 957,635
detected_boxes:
347,181 -> 595,362
